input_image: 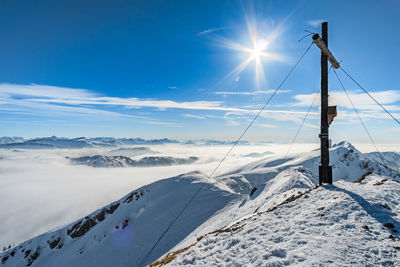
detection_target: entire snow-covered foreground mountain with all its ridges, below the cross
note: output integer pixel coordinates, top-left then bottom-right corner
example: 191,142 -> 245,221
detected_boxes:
0,142 -> 400,266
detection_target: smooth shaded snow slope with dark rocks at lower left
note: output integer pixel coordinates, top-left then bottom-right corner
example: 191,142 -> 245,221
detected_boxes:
0,173 -> 239,266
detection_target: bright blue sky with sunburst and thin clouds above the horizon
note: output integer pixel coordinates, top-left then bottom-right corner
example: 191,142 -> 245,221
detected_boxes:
0,0 -> 400,142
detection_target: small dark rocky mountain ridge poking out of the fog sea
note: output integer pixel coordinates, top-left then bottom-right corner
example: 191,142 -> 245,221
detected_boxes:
67,155 -> 199,167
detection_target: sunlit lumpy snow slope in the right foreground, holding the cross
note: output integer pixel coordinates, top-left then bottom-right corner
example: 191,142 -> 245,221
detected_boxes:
169,175 -> 400,266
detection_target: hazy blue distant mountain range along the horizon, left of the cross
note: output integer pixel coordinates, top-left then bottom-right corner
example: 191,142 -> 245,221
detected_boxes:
0,136 -> 270,149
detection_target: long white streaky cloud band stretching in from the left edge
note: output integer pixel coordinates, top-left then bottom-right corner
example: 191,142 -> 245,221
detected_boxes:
0,84 -> 304,114
